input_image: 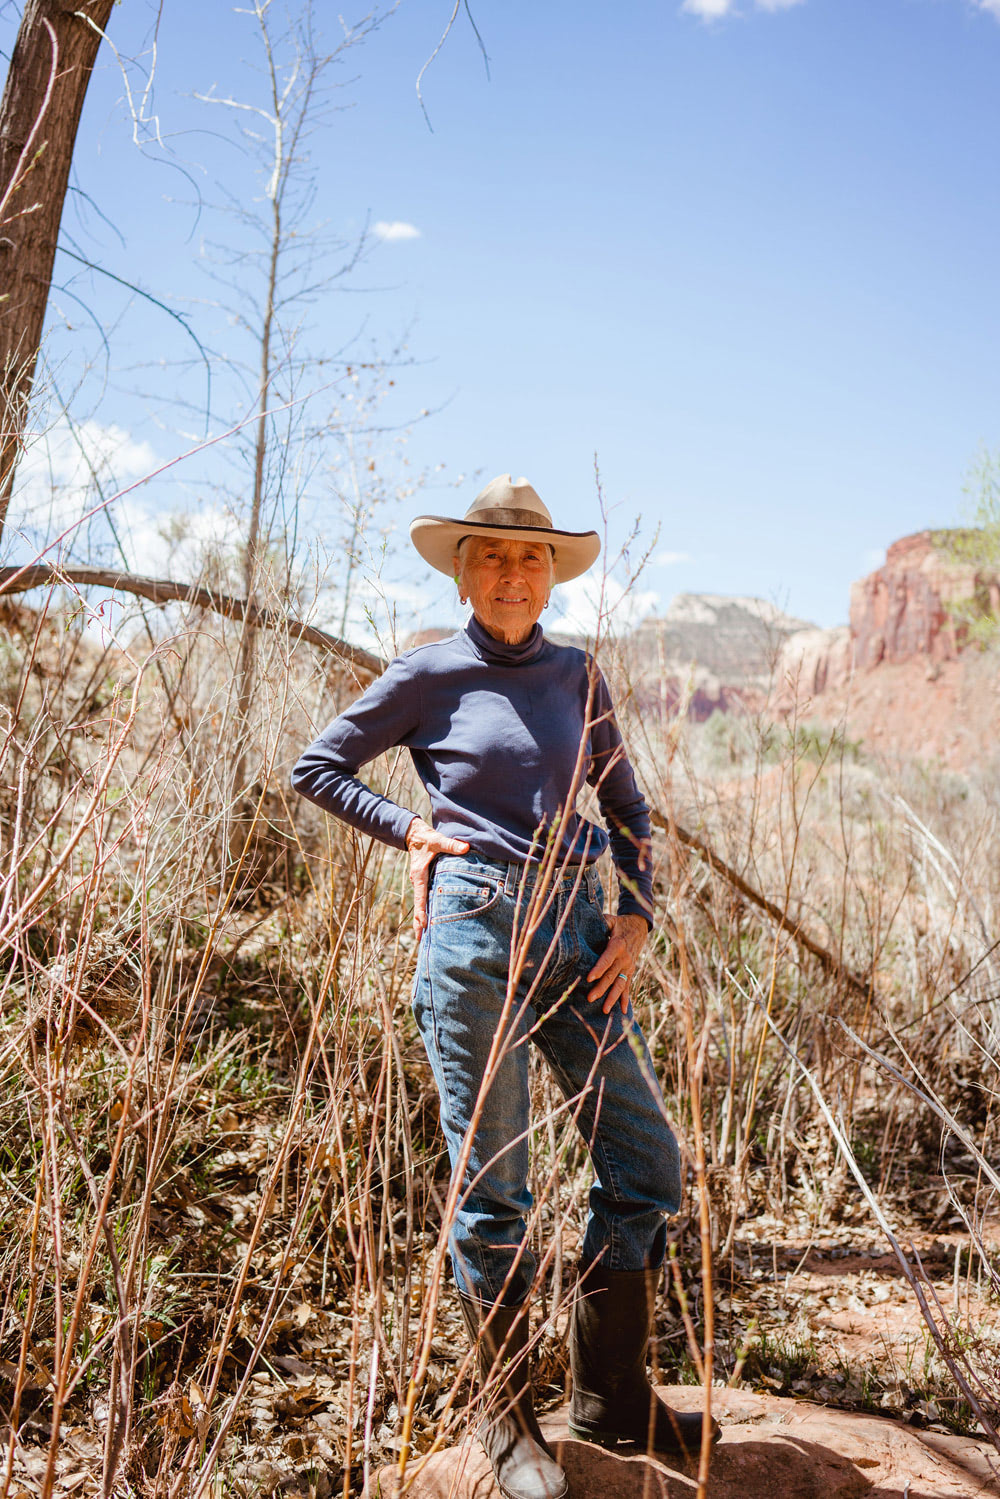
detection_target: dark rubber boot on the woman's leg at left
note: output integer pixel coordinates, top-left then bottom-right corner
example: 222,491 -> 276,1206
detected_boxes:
459,1295 -> 567,1499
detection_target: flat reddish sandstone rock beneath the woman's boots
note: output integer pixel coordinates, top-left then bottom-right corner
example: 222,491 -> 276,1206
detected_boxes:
373,1385 -> 1000,1499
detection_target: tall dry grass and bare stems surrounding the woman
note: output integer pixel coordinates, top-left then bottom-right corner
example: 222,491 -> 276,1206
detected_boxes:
0,584 -> 1000,1499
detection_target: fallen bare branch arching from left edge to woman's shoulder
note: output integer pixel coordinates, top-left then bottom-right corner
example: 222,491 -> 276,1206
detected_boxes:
0,562 -> 385,676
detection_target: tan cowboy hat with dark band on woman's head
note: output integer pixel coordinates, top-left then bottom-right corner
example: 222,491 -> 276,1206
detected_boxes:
409,474 -> 601,583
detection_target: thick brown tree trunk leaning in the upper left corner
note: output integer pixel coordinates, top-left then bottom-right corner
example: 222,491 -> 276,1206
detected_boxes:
0,0 -> 114,535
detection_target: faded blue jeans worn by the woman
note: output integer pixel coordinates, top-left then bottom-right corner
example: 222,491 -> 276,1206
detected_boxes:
414,854 -> 681,1306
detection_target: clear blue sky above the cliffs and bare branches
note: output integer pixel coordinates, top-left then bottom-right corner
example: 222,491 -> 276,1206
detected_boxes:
1,0 -> 1000,635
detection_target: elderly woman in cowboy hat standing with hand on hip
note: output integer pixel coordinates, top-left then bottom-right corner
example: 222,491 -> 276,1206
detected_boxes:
292,474 -> 702,1499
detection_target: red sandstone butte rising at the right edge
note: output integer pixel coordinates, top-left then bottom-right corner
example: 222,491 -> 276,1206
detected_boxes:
772,531 -> 1000,770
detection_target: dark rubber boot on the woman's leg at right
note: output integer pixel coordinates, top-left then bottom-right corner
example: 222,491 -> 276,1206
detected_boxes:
570,1265 -> 720,1462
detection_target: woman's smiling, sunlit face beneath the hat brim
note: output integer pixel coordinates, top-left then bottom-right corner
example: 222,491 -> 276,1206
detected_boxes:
454,537 -> 553,646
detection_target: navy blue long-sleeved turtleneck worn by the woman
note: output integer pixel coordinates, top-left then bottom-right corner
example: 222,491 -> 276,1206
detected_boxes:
292,618 -> 652,920
